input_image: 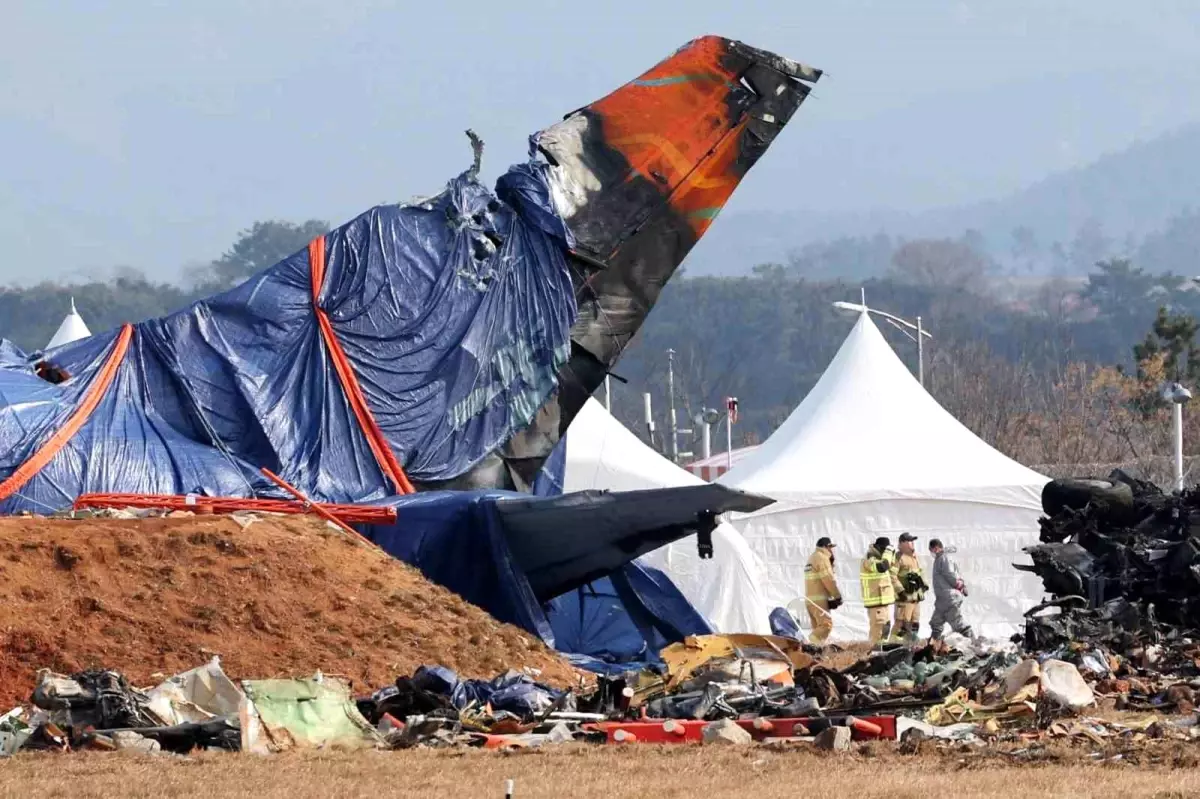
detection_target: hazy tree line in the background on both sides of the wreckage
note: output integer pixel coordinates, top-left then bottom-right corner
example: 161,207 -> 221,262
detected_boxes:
7,217 -> 1200,479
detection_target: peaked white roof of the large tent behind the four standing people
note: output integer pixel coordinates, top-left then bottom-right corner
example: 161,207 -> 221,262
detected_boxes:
719,304 -> 1046,499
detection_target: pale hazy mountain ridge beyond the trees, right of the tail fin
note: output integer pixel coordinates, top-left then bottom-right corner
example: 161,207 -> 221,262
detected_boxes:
689,125 -> 1200,278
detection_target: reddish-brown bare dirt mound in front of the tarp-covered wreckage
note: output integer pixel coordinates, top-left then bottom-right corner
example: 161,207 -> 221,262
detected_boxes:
0,516 -> 575,711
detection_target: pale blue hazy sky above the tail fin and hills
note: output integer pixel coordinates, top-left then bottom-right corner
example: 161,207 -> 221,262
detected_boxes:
0,0 -> 1200,282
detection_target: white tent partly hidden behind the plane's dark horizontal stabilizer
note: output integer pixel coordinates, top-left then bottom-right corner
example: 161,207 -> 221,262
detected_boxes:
563,400 -> 770,633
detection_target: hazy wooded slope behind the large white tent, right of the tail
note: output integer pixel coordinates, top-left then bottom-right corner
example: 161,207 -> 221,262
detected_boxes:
612,249 -> 1200,463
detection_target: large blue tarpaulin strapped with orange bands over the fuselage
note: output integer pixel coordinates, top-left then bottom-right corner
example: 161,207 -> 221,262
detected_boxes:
0,163 -> 576,513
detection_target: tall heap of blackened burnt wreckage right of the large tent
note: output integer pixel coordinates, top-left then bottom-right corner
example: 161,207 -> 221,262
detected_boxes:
1016,471 -> 1200,650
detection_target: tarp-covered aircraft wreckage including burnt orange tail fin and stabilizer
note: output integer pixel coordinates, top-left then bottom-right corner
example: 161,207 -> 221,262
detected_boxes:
0,36 -> 821,637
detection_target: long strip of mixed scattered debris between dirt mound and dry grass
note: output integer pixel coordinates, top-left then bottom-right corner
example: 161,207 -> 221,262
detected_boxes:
7,635 -> 1200,758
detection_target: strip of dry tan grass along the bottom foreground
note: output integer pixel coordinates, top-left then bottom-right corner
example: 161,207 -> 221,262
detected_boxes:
0,745 -> 1200,799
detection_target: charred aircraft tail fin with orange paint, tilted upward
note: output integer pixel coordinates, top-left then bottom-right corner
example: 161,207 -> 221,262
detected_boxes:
436,36 -> 821,489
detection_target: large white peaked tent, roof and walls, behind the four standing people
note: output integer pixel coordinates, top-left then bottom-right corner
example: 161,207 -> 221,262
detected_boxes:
718,313 -> 1049,639
